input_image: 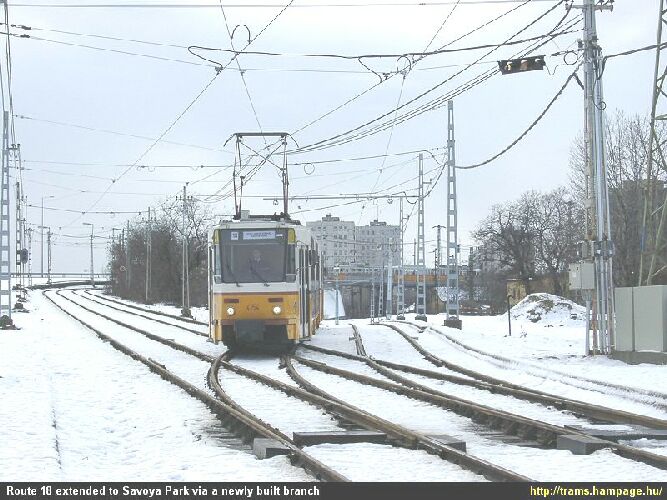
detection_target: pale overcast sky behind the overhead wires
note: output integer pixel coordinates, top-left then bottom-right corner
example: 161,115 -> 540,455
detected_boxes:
9,0 -> 658,271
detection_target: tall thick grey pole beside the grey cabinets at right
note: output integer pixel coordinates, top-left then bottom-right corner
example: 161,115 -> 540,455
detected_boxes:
573,0 -> 614,354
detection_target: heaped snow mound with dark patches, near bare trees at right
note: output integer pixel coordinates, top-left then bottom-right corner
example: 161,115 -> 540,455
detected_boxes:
511,293 -> 586,326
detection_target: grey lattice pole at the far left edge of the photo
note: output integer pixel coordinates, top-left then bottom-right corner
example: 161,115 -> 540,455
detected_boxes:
0,111 -> 14,330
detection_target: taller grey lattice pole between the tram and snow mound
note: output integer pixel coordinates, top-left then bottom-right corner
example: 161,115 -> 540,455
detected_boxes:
446,101 -> 459,320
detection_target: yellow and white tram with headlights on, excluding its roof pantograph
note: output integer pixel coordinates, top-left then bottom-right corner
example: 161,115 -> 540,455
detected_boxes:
209,213 -> 323,349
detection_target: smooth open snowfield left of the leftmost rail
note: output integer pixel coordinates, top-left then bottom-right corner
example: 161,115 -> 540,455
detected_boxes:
0,292 -> 312,482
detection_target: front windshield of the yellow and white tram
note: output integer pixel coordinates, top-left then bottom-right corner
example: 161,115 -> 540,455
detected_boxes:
220,229 -> 287,284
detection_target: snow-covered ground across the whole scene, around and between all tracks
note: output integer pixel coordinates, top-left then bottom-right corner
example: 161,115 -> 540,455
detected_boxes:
5,291 -> 667,481
